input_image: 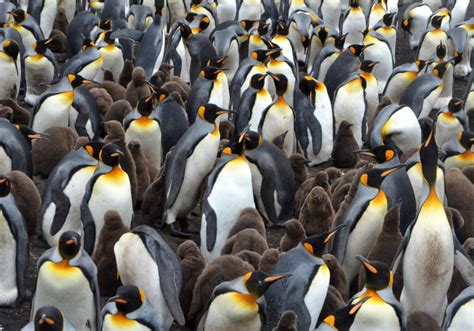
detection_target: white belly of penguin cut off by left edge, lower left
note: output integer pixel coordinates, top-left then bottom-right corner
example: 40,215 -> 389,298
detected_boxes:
0,210 -> 18,306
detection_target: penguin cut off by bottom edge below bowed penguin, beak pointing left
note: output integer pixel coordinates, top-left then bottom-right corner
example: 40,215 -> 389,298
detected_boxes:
101,285 -> 164,331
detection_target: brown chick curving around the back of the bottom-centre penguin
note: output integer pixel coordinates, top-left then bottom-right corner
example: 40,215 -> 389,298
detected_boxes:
188,255 -> 254,325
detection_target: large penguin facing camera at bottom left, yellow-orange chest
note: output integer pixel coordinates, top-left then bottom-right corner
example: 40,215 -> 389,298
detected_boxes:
31,231 -> 100,331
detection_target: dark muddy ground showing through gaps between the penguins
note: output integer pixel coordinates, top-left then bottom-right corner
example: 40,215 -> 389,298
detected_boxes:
0,2 -> 474,331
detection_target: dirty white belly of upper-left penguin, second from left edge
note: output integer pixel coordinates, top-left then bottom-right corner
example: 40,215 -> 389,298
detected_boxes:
25,55 -> 54,105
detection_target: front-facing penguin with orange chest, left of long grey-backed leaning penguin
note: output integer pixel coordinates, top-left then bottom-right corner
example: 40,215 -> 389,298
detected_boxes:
123,95 -> 164,169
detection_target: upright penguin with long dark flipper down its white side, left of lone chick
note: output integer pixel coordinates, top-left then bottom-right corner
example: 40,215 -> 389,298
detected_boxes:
295,76 -> 334,166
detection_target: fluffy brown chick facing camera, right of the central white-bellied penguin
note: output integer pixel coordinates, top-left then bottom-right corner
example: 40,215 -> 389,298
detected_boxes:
298,186 -> 335,236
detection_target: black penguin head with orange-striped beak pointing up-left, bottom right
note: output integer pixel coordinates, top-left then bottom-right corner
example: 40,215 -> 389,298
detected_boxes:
356,255 -> 393,291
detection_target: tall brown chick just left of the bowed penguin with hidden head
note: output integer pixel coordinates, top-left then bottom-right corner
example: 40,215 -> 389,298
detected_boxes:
92,210 -> 129,297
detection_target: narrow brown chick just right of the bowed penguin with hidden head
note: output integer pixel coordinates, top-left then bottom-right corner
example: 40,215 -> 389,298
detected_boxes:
177,240 -> 206,316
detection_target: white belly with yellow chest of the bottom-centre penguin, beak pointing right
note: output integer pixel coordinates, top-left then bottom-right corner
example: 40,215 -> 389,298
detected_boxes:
204,292 -> 262,331
